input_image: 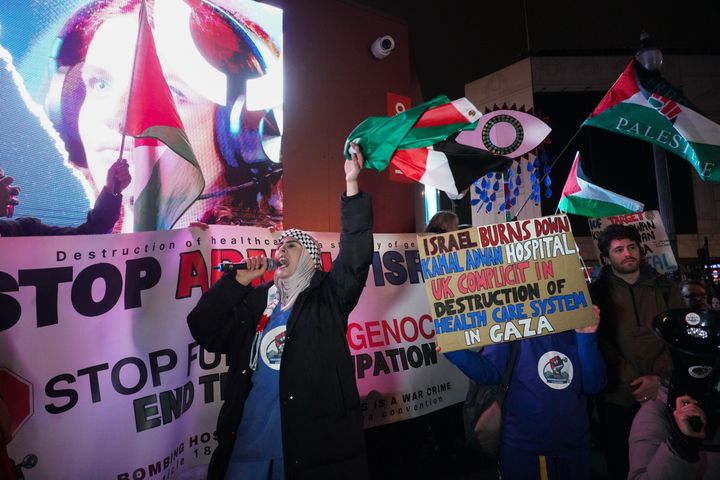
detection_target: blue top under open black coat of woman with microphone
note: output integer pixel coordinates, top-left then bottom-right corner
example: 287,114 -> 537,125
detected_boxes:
225,306 -> 292,480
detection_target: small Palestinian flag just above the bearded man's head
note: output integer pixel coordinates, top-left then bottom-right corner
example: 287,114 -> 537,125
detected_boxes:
558,152 -> 644,218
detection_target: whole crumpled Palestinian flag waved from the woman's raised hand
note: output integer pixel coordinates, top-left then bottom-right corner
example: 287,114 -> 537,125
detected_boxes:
345,96 -> 512,198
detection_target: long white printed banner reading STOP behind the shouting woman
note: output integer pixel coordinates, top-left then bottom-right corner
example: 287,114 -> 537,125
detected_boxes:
0,226 -> 467,480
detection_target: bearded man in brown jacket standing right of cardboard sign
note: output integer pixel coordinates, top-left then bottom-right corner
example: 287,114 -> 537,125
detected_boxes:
590,225 -> 685,480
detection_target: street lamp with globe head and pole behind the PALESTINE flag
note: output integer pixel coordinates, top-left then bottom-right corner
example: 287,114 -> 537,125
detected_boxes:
635,30 -> 679,262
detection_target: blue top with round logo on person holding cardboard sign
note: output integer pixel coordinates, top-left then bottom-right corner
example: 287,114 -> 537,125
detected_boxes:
446,330 -> 605,455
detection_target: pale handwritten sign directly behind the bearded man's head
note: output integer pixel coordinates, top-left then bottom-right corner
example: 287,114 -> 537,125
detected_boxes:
588,210 -> 677,273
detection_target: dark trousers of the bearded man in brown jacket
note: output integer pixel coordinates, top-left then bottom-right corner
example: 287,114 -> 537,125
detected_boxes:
598,399 -> 638,480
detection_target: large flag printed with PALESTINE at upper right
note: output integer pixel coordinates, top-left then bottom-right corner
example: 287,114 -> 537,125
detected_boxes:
583,59 -> 720,182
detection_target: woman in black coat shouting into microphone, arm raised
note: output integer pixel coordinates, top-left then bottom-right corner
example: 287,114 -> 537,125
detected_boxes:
188,145 -> 373,480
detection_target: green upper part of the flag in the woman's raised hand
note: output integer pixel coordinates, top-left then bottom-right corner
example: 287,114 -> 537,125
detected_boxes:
345,95 -> 481,172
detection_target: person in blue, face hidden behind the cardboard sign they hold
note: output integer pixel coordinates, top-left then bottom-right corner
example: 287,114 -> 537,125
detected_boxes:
445,306 -> 606,480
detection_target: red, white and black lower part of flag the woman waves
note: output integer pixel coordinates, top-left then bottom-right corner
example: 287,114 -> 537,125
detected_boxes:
391,141 -> 512,198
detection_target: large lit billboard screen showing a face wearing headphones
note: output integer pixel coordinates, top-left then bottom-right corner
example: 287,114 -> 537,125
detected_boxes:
0,0 -> 283,231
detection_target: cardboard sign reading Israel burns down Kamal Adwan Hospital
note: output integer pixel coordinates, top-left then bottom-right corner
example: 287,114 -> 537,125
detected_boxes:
418,215 -> 595,352
